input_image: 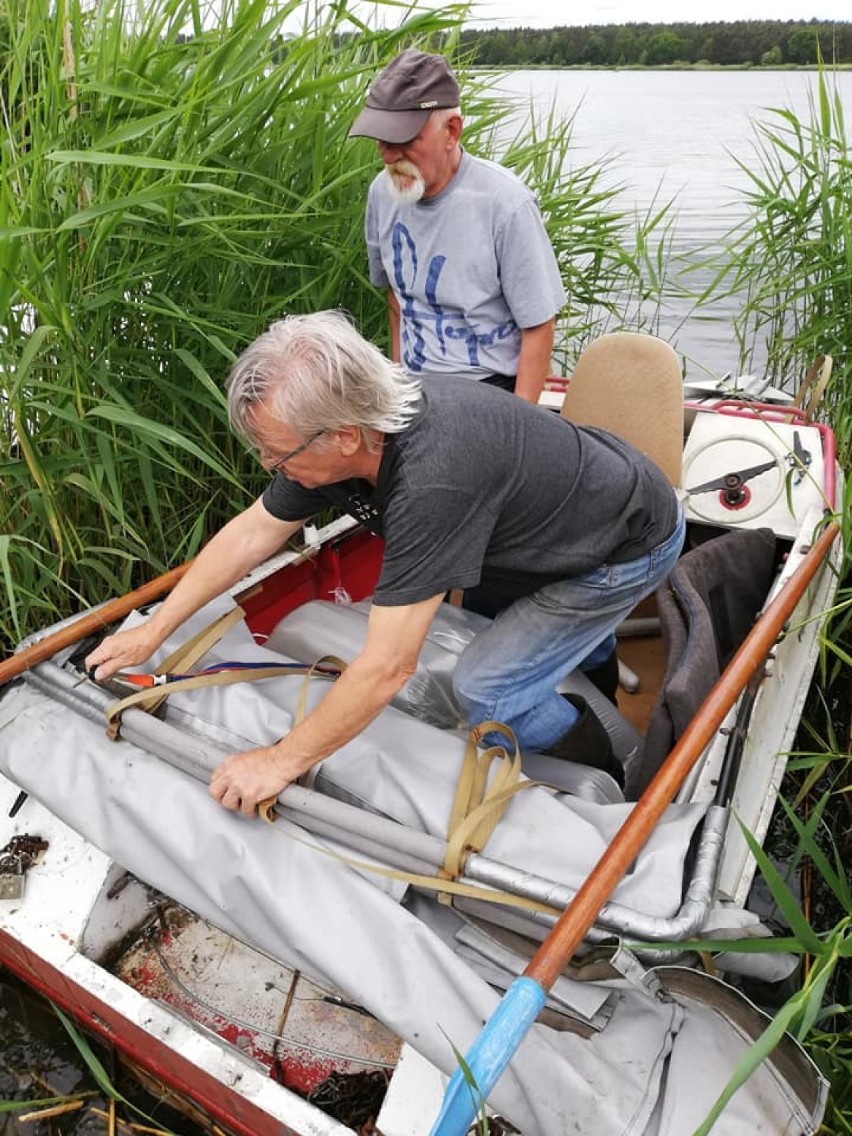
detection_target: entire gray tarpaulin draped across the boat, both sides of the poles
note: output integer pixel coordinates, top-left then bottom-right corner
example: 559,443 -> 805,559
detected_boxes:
0,611 -> 821,1136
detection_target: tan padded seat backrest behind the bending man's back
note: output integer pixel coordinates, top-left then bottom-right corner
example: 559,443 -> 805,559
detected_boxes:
560,332 -> 684,486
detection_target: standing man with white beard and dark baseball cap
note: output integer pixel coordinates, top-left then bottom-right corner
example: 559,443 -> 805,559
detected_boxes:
349,49 -> 565,402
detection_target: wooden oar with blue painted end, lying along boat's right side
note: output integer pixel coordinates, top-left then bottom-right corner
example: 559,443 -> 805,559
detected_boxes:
432,521 -> 840,1136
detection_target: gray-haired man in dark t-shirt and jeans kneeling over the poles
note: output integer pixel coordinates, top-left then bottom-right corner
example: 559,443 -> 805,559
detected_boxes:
86,311 -> 684,815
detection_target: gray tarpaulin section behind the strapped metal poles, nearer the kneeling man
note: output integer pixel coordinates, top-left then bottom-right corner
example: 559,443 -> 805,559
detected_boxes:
136,605 -> 704,916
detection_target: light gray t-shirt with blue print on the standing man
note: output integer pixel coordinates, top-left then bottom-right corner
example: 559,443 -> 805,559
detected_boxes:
365,152 -> 566,378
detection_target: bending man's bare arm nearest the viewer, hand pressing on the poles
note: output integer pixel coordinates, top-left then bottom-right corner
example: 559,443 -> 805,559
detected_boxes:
210,592 -> 444,817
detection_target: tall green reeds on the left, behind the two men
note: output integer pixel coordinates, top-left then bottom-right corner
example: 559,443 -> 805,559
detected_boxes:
0,0 -> 672,646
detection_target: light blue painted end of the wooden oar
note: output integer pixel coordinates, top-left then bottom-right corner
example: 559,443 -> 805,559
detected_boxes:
431,975 -> 548,1136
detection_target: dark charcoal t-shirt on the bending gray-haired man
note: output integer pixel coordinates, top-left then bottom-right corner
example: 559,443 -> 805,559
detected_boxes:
264,377 -> 677,605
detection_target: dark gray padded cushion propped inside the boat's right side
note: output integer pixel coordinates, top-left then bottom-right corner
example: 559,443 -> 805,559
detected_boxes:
625,528 -> 776,800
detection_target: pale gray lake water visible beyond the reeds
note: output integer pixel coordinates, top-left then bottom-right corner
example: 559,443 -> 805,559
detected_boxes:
496,70 -> 852,374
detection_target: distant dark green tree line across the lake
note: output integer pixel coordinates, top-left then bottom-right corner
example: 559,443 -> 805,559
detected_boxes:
461,19 -> 852,67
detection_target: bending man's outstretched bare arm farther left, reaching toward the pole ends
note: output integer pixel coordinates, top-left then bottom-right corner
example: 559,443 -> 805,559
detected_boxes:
85,499 -> 304,680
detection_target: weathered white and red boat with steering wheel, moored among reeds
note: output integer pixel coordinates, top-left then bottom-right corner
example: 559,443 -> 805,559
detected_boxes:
0,374 -> 842,1136
